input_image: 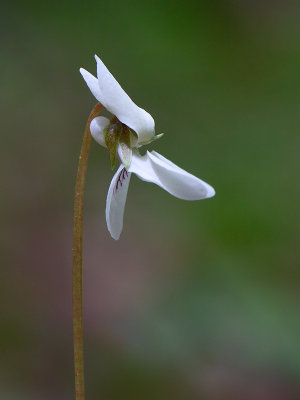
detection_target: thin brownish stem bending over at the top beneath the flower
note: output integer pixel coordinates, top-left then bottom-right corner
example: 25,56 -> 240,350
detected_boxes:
72,103 -> 103,400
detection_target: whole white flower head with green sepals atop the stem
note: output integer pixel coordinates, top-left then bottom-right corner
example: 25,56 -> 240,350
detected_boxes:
80,56 -> 215,240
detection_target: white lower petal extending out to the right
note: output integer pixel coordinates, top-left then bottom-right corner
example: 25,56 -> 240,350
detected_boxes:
129,151 -> 215,200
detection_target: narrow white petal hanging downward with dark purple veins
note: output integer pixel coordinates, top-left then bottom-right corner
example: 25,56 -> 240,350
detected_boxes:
106,164 -> 131,240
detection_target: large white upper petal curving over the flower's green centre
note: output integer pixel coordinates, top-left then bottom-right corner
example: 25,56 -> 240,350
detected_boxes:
92,56 -> 154,142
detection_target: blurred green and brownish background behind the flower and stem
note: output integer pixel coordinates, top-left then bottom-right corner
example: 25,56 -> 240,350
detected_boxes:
0,0 -> 300,400
